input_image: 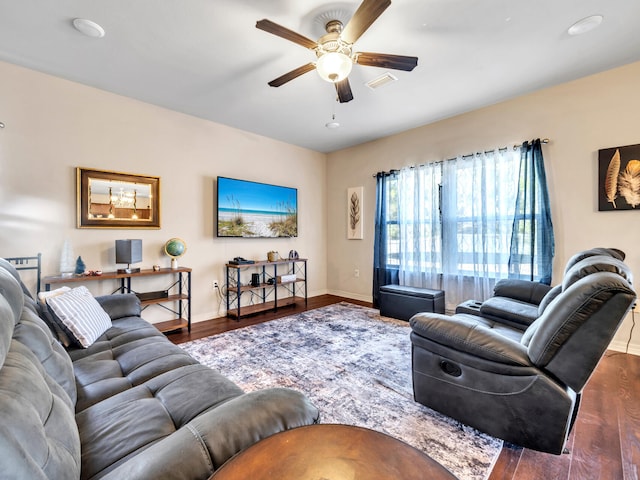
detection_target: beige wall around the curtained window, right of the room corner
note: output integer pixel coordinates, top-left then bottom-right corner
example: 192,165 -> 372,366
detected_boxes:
327,63 -> 640,354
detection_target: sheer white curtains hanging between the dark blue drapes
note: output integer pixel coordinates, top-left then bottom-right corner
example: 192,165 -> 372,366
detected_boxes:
398,150 -> 519,309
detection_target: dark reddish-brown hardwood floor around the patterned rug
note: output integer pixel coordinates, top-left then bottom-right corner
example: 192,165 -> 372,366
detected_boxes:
168,295 -> 640,480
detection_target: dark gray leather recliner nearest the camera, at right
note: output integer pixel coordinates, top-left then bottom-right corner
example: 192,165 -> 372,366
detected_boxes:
410,255 -> 636,454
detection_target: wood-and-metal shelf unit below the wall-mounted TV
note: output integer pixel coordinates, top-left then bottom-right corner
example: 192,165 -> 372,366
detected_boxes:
226,258 -> 307,321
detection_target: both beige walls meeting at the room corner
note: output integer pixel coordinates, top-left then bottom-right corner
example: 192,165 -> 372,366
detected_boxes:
0,58 -> 640,353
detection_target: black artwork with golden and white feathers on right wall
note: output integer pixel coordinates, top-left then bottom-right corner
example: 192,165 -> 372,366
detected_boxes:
598,144 -> 640,212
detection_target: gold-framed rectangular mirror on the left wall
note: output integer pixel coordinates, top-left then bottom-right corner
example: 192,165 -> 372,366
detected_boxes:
76,167 -> 160,228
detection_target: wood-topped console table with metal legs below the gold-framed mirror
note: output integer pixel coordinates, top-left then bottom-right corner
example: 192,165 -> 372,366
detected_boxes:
43,267 -> 191,332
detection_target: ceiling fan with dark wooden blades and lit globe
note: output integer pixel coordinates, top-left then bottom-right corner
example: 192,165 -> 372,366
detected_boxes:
256,0 -> 418,103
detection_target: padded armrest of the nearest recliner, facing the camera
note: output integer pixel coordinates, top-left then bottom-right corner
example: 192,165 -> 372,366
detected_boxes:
409,313 -> 531,366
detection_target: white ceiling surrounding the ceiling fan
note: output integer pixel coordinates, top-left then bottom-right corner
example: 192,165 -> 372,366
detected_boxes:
0,0 -> 640,152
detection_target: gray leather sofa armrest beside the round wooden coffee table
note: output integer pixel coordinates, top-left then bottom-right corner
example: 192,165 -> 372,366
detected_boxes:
101,388 -> 319,480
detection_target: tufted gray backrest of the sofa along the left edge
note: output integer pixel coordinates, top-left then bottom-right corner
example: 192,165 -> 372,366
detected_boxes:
0,268 -> 80,479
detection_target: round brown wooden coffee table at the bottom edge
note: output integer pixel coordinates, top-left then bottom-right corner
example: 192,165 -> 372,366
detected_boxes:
210,424 -> 456,480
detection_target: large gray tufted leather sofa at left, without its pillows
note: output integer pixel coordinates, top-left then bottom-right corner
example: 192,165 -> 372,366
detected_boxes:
0,259 -> 319,480
